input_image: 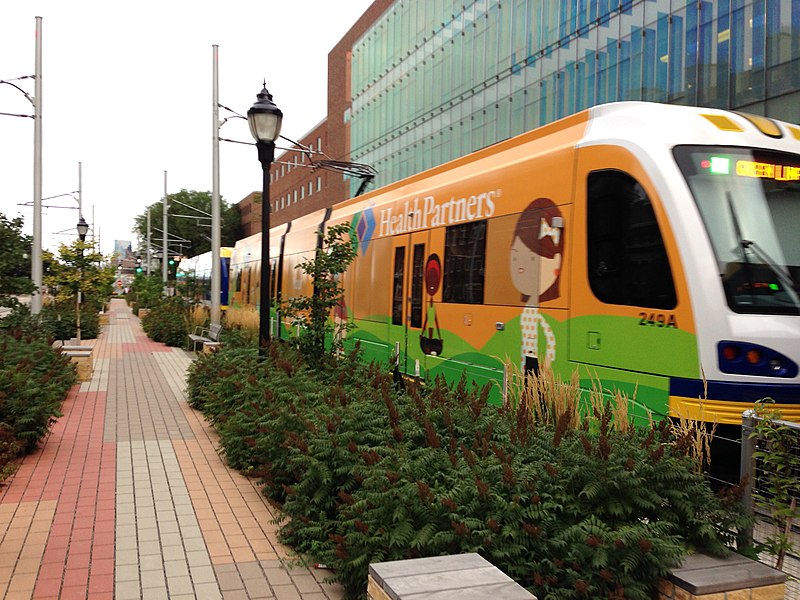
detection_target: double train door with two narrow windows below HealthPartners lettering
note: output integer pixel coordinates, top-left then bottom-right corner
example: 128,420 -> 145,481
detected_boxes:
389,231 -> 428,375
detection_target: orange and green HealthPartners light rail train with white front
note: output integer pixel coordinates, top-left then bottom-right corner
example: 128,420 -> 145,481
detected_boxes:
231,102 -> 800,424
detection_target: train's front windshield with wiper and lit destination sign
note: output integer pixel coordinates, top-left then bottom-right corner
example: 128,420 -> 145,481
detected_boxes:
674,146 -> 800,315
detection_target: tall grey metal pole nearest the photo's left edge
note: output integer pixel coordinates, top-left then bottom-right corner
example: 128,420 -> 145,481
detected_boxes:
31,17 -> 43,315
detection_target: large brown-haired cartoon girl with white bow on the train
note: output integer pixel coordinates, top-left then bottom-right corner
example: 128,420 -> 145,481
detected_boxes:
510,198 -> 564,374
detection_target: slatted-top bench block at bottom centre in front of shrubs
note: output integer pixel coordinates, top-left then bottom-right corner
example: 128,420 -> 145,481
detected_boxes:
367,553 -> 536,600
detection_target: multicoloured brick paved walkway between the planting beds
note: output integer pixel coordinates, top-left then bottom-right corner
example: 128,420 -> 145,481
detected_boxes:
0,299 -> 342,600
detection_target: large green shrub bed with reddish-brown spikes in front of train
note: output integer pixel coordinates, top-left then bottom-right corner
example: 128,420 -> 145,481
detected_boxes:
189,344 -> 747,599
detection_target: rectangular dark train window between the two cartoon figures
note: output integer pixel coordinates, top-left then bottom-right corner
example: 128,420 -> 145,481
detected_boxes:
442,221 -> 486,304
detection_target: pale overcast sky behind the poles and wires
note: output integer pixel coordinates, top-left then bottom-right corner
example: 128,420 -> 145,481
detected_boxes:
0,0 -> 372,253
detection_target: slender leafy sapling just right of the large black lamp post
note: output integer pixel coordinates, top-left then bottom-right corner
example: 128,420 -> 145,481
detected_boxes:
285,223 -> 356,365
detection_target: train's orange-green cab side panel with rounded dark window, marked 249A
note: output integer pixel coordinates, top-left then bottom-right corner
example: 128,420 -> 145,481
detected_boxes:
569,148 -> 697,422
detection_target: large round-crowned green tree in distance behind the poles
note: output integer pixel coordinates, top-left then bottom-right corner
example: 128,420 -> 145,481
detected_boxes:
134,190 -> 241,256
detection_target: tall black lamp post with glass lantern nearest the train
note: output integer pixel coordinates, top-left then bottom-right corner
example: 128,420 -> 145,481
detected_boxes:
247,82 -> 283,358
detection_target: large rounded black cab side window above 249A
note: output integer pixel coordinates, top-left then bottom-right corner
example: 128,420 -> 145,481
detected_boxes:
587,171 -> 677,309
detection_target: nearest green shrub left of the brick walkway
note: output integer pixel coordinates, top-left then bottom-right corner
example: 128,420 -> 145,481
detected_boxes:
0,329 -> 76,452
